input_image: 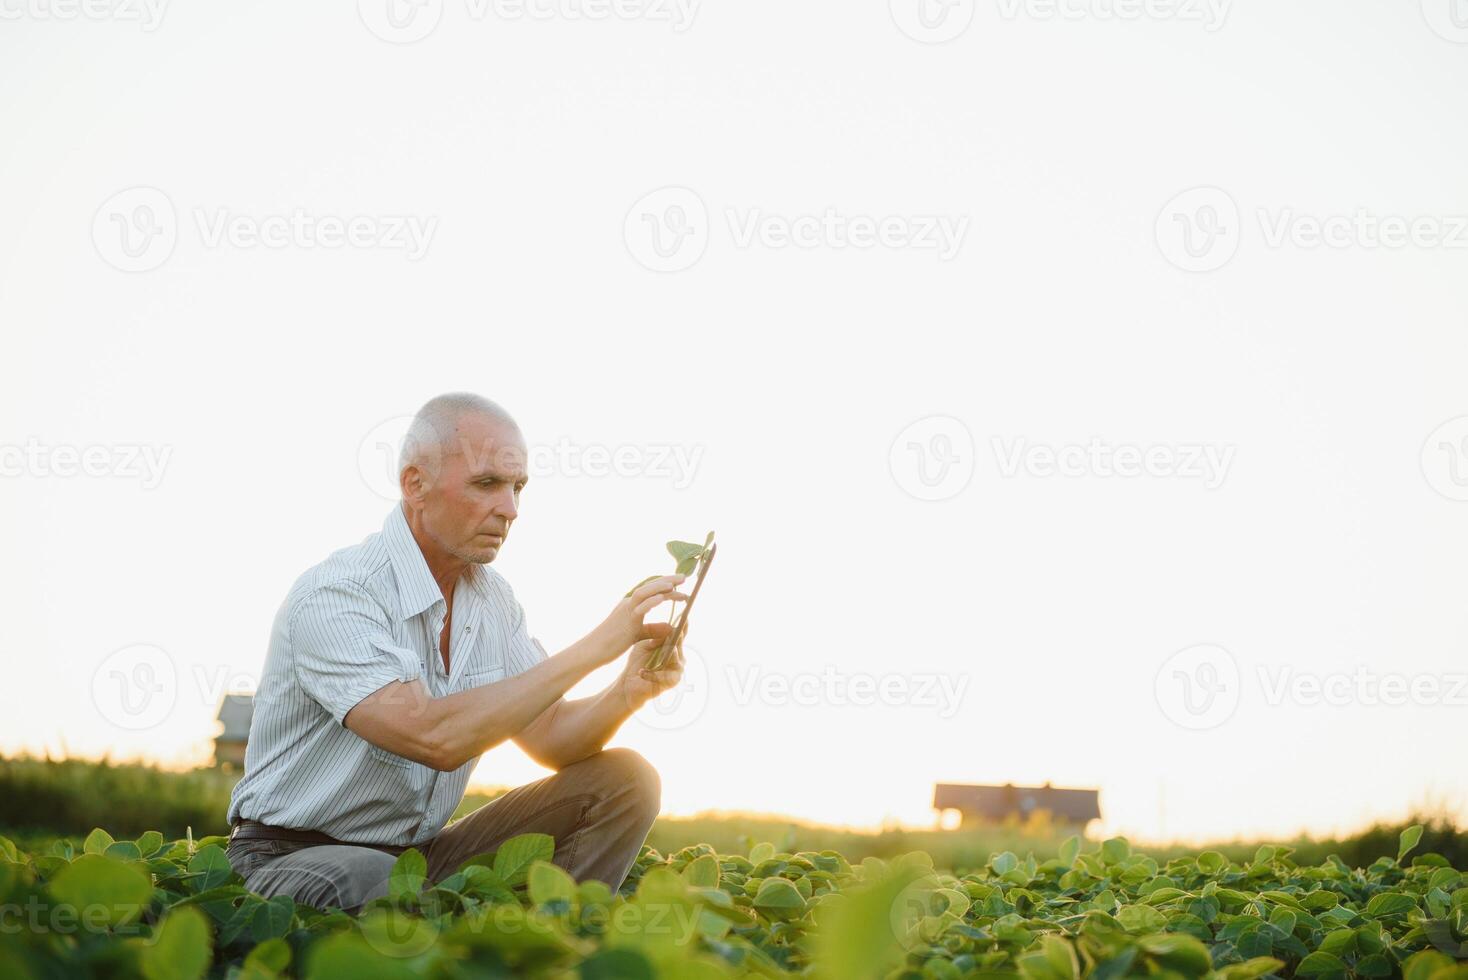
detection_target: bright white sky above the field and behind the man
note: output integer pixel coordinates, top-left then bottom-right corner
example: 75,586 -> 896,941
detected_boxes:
0,0 -> 1468,838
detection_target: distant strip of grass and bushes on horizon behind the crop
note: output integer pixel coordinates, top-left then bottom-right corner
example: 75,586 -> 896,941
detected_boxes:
0,757 -> 1468,873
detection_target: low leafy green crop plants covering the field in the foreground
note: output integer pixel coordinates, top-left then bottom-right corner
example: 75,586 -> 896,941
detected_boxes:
0,827 -> 1468,980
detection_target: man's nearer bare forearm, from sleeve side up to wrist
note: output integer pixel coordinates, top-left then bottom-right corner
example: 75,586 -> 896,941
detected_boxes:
426,629 -> 625,772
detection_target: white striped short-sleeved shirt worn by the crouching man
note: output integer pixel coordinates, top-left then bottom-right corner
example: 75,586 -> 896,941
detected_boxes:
229,503 -> 546,845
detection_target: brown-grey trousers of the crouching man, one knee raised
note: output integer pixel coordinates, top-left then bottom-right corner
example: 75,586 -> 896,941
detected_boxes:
229,748 -> 661,913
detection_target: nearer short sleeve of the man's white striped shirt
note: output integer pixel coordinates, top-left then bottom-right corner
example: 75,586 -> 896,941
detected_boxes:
291,581 -> 423,725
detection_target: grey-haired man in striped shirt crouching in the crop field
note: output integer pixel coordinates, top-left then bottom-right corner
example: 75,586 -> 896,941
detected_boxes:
229,395 -> 684,911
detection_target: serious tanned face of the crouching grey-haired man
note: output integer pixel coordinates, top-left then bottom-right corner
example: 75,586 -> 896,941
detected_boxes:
410,414 -> 528,565
